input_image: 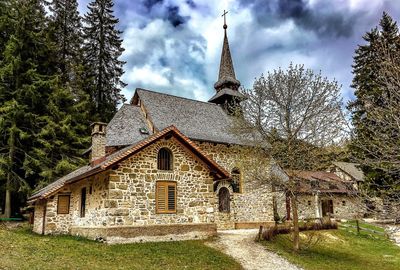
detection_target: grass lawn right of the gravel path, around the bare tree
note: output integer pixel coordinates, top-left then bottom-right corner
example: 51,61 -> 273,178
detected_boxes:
263,223 -> 400,270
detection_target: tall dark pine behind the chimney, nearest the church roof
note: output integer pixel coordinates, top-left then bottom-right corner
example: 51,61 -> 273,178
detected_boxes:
84,0 -> 126,122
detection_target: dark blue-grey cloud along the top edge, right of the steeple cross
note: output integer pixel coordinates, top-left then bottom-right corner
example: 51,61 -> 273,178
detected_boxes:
240,0 -> 359,37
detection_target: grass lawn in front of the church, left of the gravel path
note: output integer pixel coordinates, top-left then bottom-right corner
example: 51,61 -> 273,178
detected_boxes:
0,226 -> 241,270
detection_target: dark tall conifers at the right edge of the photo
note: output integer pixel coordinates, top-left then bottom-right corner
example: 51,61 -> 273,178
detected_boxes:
348,12 -> 400,195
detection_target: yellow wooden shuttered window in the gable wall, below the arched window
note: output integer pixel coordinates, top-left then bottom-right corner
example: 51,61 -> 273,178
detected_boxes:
156,181 -> 176,214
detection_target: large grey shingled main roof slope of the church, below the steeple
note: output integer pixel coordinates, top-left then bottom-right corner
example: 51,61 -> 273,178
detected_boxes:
136,89 -> 260,145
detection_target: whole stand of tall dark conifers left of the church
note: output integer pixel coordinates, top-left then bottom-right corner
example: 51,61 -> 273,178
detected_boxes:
0,0 -> 125,217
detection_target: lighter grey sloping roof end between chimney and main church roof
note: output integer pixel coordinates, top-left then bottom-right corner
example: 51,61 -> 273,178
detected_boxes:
106,104 -> 149,146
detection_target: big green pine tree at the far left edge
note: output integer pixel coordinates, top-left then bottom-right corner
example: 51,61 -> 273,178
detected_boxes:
0,0 -> 51,217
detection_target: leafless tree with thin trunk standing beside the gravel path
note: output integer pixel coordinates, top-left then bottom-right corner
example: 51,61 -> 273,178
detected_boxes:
237,64 -> 346,250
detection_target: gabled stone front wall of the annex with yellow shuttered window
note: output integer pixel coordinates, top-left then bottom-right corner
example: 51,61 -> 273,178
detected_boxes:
103,138 -> 215,229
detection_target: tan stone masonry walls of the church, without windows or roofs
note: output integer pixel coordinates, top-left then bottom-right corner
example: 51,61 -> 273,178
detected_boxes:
34,137 -> 273,242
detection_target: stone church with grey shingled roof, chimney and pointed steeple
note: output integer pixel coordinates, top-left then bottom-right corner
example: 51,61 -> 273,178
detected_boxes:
28,19 -> 280,243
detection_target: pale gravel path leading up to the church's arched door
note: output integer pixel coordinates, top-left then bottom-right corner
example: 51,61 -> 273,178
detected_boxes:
208,230 -> 301,270
